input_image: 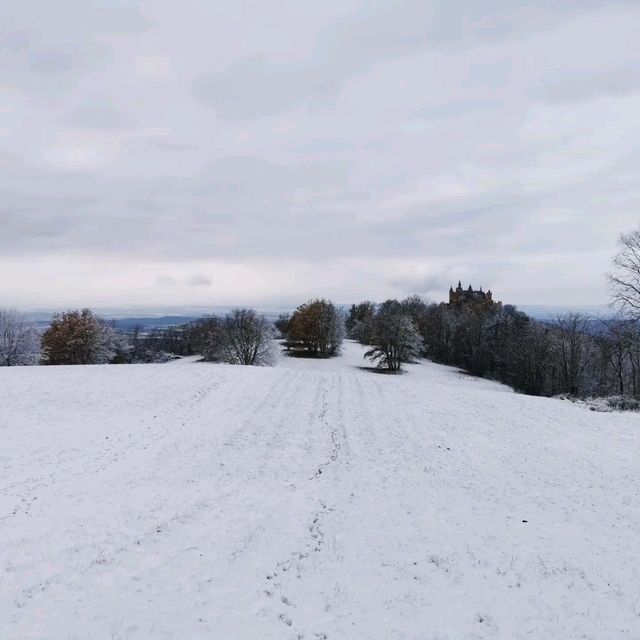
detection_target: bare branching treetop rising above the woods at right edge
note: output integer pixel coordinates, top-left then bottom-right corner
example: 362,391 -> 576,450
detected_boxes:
609,228 -> 640,318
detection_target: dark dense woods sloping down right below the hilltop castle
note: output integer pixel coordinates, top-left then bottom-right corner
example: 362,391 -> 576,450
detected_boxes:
347,296 -> 640,399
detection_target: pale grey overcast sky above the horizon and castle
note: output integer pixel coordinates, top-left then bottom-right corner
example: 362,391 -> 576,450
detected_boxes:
0,0 -> 640,308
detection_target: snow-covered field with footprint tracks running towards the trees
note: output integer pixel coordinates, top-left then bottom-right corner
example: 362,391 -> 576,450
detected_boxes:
0,343 -> 640,640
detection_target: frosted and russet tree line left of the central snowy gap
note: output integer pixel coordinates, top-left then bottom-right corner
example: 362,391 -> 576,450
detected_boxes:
0,300 -> 344,366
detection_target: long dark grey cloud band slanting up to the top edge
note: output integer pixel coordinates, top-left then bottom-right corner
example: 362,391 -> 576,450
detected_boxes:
193,0 -> 624,121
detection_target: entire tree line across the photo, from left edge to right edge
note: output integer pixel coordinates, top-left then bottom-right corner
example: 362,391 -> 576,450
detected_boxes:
0,229 -> 640,400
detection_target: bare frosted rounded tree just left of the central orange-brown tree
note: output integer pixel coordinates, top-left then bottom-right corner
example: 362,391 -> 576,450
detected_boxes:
218,309 -> 275,366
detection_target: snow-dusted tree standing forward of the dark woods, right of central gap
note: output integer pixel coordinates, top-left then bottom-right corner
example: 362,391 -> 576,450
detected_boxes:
364,300 -> 424,371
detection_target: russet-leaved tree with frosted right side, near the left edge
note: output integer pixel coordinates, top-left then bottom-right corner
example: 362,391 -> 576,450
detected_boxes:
42,309 -> 126,364
